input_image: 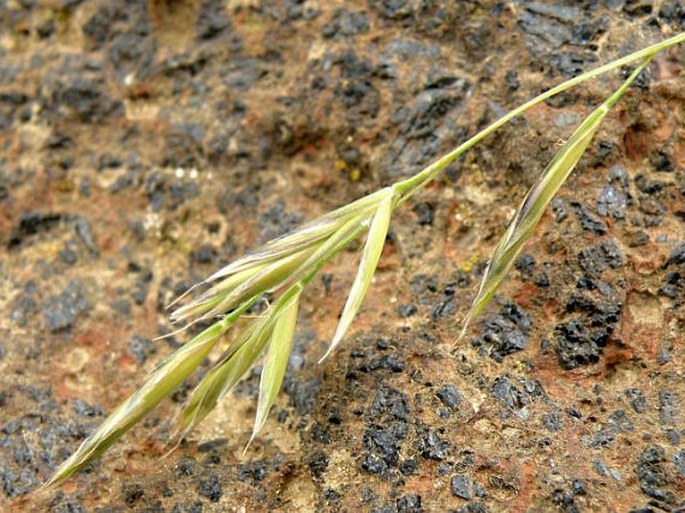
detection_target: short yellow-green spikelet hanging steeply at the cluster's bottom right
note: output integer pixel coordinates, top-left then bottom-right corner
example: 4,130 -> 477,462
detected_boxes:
245,284 -> 300,444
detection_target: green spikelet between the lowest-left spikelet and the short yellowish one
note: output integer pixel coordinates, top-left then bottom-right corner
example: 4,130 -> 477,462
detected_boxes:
177,283 -> 302,437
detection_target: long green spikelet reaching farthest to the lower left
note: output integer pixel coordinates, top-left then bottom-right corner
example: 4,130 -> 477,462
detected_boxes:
46,301 -> 254,486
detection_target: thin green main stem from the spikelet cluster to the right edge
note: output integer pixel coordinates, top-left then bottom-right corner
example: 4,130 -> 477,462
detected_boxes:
394,32 -> 685,203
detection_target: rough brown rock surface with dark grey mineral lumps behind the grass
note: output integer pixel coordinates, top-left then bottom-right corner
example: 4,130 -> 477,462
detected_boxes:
0,0 -> 685,513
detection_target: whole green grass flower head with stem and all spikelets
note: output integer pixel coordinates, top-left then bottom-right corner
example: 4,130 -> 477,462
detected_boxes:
48,33 -> 685,485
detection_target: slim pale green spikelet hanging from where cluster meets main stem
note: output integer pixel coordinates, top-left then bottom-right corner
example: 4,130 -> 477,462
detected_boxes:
319,187 -> 396,362
